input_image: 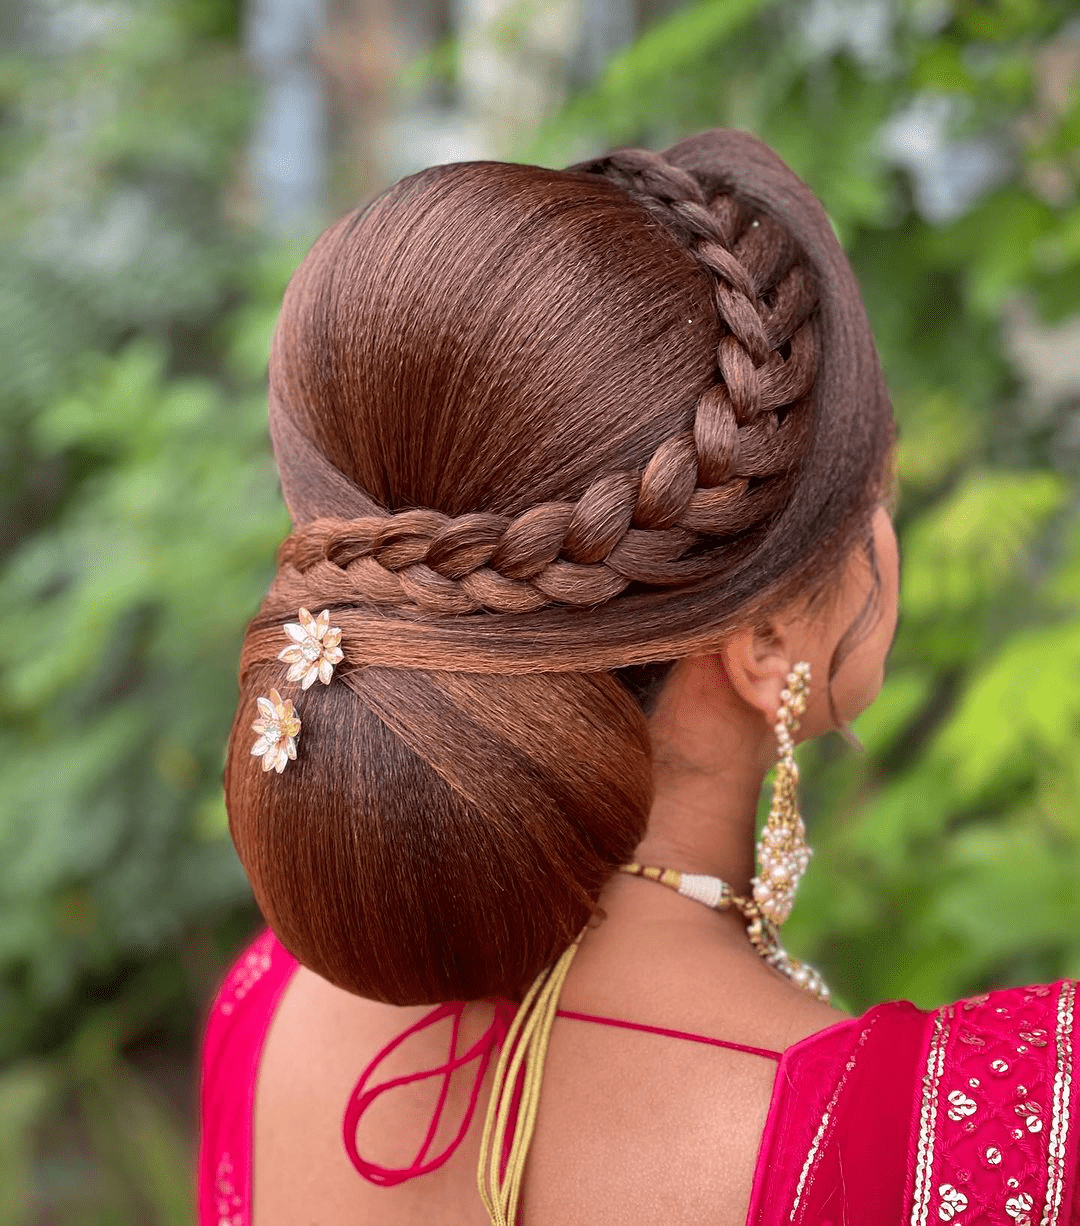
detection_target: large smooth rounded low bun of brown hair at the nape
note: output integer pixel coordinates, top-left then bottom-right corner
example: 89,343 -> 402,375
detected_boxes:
226,657 -> 652,1005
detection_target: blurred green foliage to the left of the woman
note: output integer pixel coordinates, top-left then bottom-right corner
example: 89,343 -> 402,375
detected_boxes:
0,0 -> 290,1211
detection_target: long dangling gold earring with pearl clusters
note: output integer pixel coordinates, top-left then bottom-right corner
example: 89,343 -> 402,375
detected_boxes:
750,661 -> 810,926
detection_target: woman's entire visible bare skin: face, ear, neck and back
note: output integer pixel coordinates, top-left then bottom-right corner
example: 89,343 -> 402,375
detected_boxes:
254,510 -> 899,1226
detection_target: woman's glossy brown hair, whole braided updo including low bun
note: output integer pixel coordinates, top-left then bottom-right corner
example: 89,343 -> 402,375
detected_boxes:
226,131 -> 891,1004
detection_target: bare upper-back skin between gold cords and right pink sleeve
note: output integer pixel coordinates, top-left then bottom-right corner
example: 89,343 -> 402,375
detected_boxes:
525,927 -> 845,1226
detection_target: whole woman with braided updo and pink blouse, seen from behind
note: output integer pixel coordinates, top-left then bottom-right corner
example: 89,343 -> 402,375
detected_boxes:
200,131 -> 1080,1226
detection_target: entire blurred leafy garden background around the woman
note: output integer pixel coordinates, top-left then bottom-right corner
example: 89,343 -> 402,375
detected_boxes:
0,0 -> 1080,1226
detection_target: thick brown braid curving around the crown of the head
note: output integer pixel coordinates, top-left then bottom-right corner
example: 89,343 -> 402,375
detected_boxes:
278,150 -> 818,614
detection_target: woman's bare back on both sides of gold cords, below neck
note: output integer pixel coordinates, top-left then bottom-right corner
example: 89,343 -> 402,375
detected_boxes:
254,929 -> 843,1226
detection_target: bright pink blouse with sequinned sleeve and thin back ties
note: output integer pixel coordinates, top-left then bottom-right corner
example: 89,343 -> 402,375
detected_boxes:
197,932 -> 1080,1226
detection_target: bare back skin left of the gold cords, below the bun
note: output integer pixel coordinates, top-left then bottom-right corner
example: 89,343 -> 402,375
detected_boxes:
253,967 -> 492,1226
